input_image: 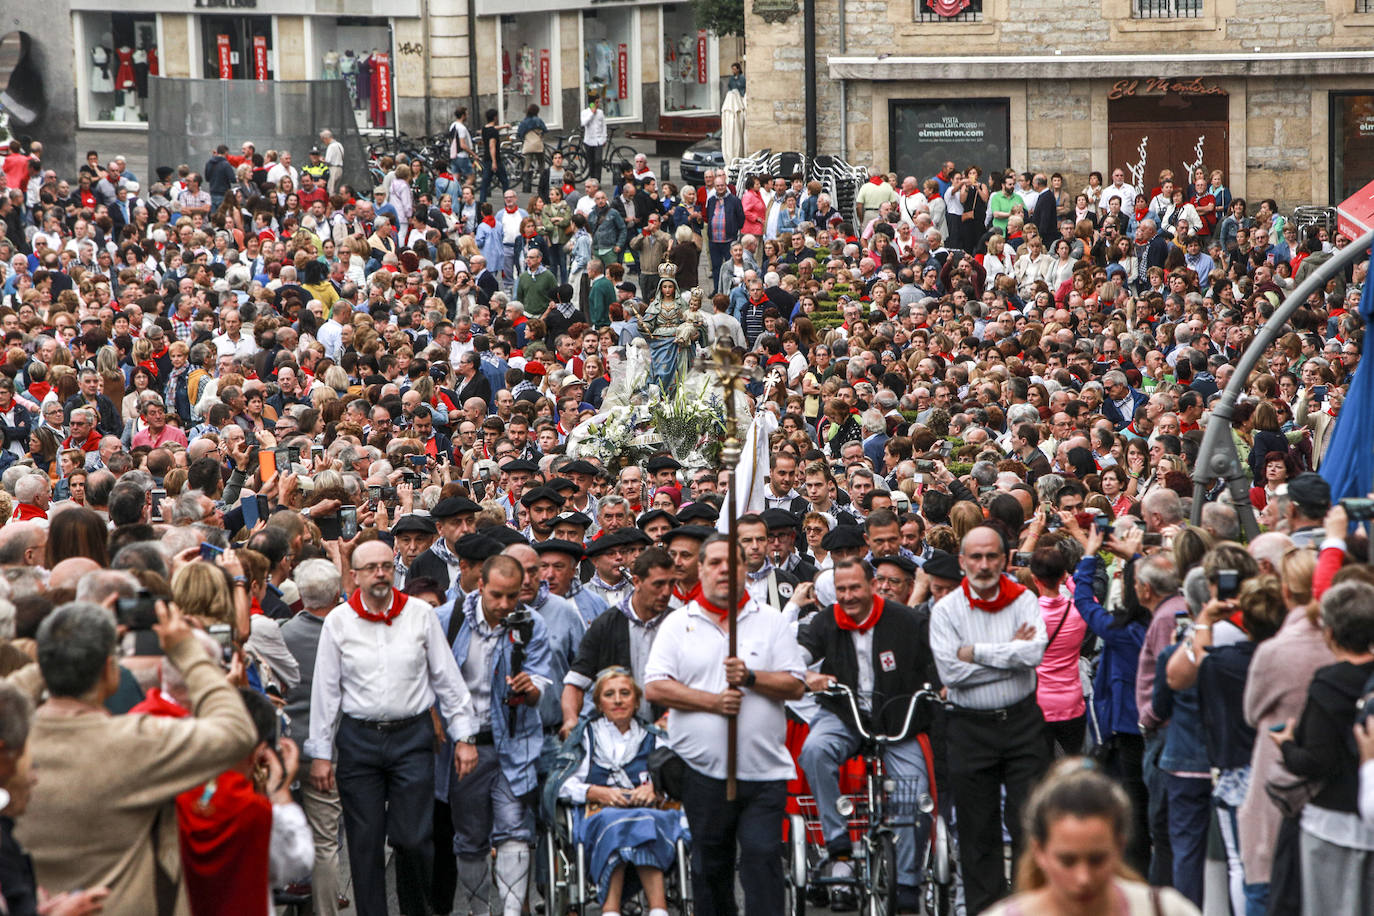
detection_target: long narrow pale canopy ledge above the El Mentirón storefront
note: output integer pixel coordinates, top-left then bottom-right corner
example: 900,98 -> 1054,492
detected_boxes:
827,51 -> 1374,81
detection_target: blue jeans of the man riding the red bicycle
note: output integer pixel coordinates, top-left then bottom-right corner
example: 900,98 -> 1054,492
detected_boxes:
797,710 -> 930,886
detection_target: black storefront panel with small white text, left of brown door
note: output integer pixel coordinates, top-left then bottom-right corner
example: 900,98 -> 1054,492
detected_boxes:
889,99 -> 1011,192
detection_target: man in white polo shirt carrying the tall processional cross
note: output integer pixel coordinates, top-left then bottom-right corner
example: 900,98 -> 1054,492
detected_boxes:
644,534 -> 807,913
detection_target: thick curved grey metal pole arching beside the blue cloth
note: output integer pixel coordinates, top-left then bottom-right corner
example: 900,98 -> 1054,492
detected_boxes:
1190,229 -> 1374,538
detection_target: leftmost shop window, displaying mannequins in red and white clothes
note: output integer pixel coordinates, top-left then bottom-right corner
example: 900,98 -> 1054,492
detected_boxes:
78,12 -> 159,124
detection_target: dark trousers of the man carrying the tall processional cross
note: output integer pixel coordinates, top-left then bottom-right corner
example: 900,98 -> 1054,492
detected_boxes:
683,766 -> 787,916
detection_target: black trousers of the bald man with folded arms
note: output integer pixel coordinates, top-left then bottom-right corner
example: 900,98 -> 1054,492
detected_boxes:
949,694 -> 1050,916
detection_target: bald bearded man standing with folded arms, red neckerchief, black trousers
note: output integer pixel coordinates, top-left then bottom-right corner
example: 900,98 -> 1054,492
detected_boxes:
930,527 -> 1050,916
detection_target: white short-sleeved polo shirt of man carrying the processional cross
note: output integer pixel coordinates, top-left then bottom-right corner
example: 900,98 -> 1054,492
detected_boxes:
644,599 -> 807,781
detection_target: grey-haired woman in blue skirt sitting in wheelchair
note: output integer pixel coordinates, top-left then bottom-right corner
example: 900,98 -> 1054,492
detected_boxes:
558,667 -> 687,916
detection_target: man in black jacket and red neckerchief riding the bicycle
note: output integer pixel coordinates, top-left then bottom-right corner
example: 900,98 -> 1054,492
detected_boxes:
797,559 -> 938,911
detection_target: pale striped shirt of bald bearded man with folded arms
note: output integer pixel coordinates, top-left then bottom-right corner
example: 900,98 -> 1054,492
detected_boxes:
930,579 -> 1048,710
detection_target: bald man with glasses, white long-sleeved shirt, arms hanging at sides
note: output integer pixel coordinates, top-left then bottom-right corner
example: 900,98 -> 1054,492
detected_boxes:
306,541 -> 477,913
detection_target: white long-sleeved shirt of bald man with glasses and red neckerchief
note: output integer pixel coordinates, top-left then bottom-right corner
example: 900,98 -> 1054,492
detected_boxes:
305,597 -> 477,759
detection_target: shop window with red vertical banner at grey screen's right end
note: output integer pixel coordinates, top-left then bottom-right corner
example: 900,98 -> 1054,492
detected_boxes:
311,16 -> 396,129
